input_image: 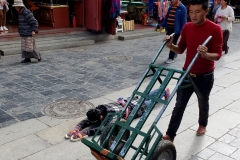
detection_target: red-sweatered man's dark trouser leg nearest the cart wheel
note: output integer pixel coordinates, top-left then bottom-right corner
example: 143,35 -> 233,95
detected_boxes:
166,82 -> 194,140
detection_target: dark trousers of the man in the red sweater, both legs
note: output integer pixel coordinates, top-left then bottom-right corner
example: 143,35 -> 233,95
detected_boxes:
166,73 -> 214,140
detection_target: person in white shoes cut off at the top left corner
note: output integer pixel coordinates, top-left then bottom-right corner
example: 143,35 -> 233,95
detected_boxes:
0,0 -> 9,32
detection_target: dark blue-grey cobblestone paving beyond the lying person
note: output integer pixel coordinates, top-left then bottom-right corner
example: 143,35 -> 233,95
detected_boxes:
0,23 -> 240,130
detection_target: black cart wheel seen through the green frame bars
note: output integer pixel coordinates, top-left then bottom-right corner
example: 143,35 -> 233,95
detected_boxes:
100,122 -> 130,155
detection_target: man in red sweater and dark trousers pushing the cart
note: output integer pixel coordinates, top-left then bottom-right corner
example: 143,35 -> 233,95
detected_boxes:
163,0 -> 223,142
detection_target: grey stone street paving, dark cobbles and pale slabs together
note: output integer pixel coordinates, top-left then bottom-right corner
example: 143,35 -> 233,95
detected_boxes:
0,23 -> 240,160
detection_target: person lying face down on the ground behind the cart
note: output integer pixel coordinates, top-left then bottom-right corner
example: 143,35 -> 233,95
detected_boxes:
65,88 -> 170,142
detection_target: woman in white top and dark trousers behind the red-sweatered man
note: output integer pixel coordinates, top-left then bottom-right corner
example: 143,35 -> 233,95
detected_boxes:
215,0 -> 235,54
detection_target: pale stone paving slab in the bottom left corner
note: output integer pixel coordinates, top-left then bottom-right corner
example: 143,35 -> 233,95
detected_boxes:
0,135 -> 50,160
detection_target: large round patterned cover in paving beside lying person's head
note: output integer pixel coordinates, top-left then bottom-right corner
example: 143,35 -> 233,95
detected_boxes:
42,100 -> 95,119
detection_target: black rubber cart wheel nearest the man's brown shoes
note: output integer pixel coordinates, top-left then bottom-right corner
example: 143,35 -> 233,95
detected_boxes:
150,140 -> 176,160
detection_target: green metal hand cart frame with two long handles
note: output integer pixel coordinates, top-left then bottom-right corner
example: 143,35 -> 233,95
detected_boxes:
82,36 -> 211,160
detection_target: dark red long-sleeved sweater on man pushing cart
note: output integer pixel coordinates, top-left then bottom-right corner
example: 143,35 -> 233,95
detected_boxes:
178,20 -> 223,74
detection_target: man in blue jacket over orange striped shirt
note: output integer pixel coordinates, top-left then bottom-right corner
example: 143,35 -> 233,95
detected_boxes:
160,0 -> 187,64
